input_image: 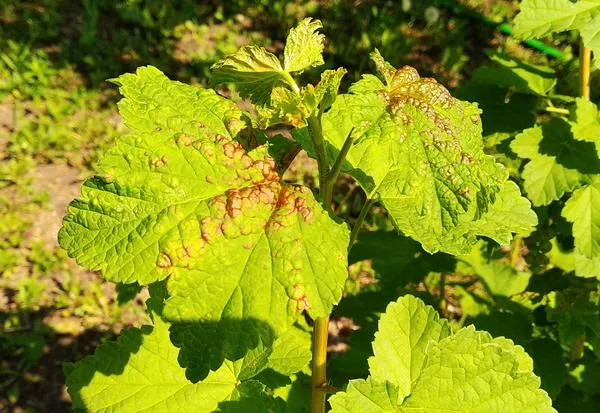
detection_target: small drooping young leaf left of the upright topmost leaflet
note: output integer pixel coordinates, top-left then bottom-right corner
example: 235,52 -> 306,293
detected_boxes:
210,46 -> 289,105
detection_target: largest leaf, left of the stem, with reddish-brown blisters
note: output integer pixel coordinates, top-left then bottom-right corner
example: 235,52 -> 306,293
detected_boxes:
59,67 -> 349,350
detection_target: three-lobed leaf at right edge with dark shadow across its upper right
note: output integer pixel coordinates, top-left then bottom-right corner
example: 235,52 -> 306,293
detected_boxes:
510,118 -> 600,206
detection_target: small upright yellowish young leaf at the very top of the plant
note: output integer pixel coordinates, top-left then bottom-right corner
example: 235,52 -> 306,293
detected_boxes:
283,18 -> 325,72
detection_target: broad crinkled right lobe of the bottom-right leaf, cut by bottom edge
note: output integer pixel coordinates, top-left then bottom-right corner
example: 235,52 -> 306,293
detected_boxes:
400,327 -> 554,413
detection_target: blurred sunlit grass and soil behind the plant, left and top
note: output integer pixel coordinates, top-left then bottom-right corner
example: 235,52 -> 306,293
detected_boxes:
0,0 -> 576,412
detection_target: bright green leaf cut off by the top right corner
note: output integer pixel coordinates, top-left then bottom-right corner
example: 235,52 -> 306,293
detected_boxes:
515,0 -> 600,64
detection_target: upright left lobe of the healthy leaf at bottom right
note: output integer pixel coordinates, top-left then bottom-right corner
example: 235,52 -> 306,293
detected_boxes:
369,295 -> 450,398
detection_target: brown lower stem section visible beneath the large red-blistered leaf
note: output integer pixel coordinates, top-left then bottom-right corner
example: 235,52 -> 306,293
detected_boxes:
310,317 -> 329,413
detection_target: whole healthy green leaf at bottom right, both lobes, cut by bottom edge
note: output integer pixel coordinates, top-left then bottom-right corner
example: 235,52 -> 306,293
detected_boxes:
330,296 -> 555,413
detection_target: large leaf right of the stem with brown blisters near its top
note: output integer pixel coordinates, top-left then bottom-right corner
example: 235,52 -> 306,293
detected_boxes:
323,53 -> 537,254
